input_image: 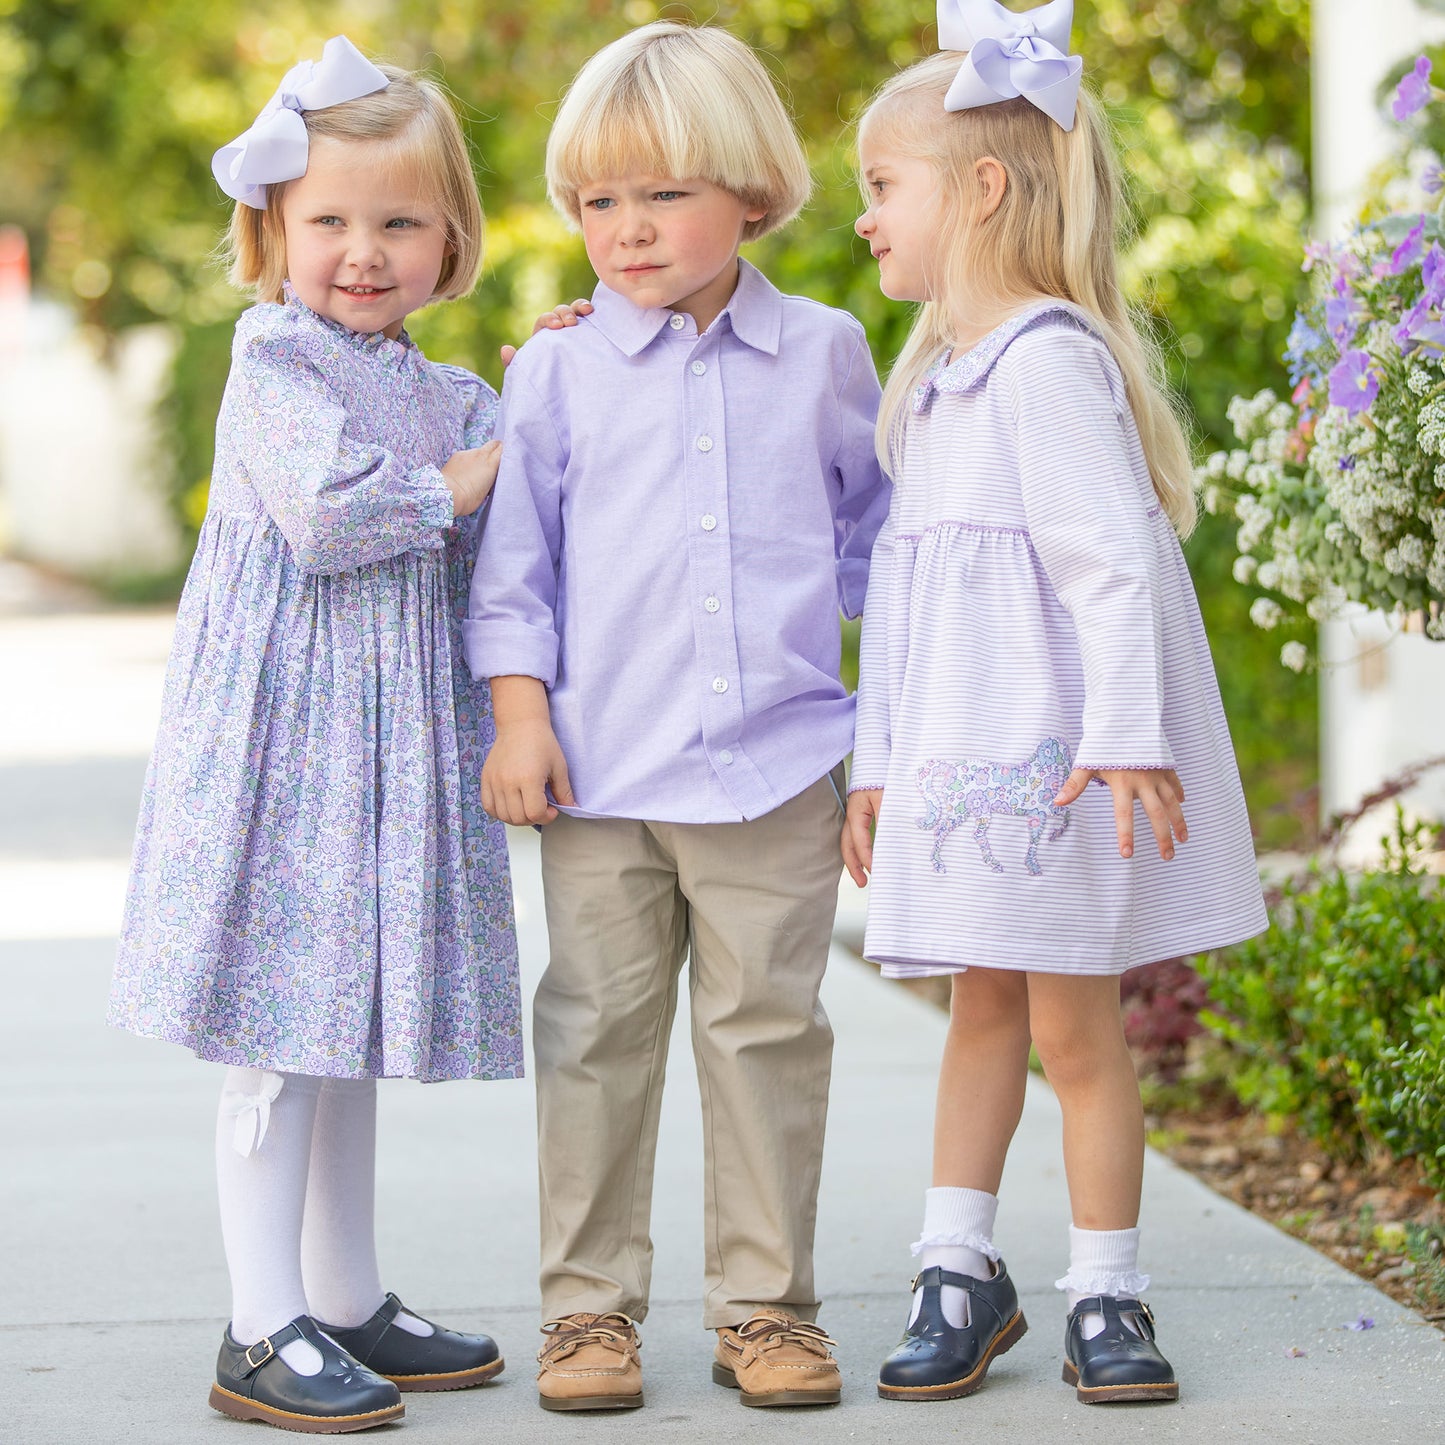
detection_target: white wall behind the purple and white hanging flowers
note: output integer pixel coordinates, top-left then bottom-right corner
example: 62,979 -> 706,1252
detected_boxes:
1312,0 -> 1445,857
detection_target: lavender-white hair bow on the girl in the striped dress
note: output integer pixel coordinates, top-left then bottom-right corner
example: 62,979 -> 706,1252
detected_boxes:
938,0 -> 1084,130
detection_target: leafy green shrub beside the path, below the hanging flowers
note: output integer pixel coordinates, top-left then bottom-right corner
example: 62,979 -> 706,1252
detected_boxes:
1199,819 -> 1445,1191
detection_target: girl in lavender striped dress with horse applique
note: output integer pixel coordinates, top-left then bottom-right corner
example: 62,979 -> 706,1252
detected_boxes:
842,0 -> 1266,1403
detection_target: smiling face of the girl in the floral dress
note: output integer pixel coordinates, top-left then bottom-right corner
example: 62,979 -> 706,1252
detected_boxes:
280,137 -> 447,341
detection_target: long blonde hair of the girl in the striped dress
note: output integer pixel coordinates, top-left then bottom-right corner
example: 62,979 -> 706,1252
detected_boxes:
858,51 -> 1196,536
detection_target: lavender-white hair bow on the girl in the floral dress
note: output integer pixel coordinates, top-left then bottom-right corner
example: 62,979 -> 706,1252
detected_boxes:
211,35 -> 387,211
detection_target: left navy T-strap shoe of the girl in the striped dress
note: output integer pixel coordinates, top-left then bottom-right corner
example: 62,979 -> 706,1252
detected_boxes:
879,1260 -> 1029,1400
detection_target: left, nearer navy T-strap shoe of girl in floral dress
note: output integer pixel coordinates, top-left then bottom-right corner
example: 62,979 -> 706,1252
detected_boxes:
211,1315 -> 406,1435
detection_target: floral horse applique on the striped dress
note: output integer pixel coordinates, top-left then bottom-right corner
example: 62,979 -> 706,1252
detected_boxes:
918,737 -> 1074,877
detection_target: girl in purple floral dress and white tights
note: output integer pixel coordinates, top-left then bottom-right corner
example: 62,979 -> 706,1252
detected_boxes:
110,36 -> 522,1433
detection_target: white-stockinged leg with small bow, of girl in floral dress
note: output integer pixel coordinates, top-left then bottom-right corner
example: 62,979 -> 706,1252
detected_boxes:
215,1068 -> 322,1374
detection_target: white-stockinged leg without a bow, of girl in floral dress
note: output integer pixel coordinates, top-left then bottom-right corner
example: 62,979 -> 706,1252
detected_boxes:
301,1079 -> 434,1335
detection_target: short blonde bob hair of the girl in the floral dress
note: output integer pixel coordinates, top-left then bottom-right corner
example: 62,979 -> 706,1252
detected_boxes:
224,65 -> 483,309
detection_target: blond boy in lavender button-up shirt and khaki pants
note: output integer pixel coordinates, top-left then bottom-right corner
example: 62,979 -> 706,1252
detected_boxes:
464,23 -> 887,1409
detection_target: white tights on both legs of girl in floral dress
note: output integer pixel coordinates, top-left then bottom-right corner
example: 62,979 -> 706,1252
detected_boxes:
215,1068 -> 432,1374
